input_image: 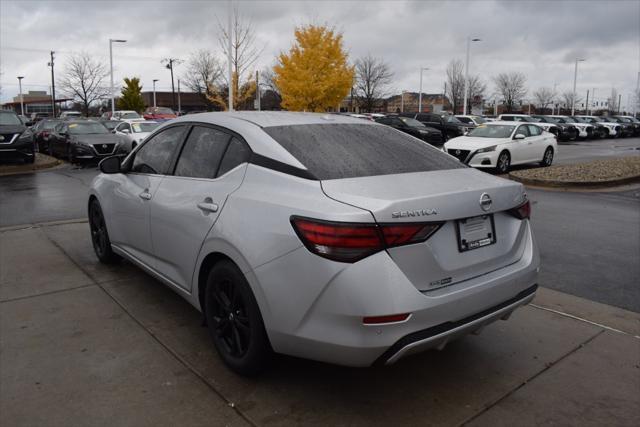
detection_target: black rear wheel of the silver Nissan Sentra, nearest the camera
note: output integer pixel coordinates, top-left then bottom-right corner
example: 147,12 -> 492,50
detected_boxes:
204,261 -> 272,376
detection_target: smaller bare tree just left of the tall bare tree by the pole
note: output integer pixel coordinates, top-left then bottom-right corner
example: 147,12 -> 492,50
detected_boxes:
182,49 -> 222,108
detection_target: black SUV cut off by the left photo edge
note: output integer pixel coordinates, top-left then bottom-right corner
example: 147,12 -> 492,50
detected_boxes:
0,111 -> 36,163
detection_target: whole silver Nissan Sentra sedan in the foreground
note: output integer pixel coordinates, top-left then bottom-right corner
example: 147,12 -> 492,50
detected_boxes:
87,112 -> 539,375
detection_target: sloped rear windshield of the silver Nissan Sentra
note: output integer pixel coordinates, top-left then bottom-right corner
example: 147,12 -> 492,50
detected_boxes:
263,123 -> 466,180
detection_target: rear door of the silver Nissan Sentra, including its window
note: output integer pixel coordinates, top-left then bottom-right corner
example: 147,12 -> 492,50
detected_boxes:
150,125 -> 250,291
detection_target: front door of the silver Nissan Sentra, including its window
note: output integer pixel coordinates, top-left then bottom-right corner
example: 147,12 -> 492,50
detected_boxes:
109,125 -> 185,267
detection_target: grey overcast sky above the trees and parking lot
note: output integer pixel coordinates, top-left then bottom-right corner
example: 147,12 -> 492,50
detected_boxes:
0,0 -> 640,106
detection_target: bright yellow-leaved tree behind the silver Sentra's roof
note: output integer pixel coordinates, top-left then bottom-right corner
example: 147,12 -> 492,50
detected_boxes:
273,25 -> 354,112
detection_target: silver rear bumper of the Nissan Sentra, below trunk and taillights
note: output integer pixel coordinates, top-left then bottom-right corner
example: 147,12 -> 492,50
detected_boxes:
252,223 -> 539,367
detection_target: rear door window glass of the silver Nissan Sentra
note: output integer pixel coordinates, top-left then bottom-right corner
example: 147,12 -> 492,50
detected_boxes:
174,126 -> 231,179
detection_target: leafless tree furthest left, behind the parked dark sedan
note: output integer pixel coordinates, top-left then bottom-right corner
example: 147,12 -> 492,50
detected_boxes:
57,52 -> 110,116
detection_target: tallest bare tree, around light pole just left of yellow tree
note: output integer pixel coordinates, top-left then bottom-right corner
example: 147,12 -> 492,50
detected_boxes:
210,9 -> 264,109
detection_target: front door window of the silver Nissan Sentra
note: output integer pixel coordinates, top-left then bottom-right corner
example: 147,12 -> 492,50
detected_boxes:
131,126 -> 184,175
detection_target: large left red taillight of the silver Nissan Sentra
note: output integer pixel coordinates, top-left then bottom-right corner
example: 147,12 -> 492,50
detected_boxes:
291,217 -> 442,262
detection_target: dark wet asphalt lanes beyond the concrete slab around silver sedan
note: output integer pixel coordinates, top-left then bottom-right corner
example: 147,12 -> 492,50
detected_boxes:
0,138 -> 640,312
